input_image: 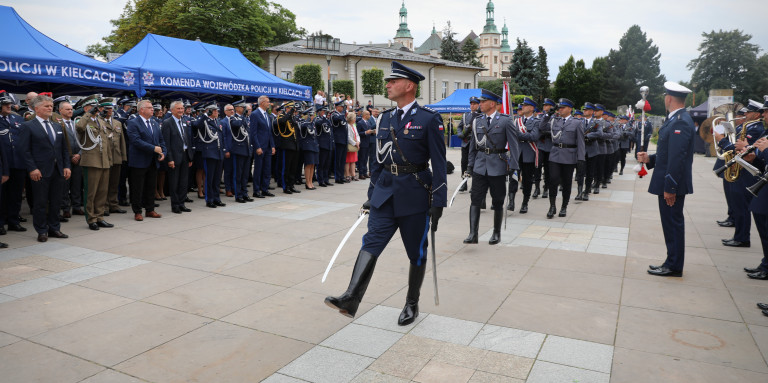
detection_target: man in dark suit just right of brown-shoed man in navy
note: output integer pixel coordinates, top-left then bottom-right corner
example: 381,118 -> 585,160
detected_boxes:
160,101 -> 195,214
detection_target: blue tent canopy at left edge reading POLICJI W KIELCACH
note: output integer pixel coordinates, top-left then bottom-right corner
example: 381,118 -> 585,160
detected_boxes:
0,6 -> 138,94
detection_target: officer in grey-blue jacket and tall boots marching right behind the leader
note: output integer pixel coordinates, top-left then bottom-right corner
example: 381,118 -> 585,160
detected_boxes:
464,89 -> 520,245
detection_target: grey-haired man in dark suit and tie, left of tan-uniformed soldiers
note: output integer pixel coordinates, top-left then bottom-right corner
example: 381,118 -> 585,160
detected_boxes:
18,96 -> 71,242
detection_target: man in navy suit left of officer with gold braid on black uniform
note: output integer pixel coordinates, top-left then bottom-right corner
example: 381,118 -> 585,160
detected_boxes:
248,96 -> 275,198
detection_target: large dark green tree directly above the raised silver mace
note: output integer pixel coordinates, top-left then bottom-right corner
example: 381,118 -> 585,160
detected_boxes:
602,25 -> 666,109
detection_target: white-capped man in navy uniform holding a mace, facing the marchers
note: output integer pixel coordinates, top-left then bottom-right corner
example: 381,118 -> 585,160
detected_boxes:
637,81 -> 696,277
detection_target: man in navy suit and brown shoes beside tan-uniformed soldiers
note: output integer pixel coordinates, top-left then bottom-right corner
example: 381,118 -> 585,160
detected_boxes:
126,100 -> 166,221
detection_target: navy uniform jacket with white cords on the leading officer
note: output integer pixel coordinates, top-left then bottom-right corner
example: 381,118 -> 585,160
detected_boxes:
368,103 -> 448,217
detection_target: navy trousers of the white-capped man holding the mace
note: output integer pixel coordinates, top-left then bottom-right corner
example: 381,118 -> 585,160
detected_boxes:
659,195 -> 685,271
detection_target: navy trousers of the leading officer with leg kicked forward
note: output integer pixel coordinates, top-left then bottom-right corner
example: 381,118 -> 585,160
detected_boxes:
361,198 -> 429,266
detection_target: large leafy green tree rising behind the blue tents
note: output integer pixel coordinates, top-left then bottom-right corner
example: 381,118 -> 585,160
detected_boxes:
86,0 -> 306,65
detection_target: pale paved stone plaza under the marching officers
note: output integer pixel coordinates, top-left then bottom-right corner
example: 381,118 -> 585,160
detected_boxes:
0,150 -> 768,383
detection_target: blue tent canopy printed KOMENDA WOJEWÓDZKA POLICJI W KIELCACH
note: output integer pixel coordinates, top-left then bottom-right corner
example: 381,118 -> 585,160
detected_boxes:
112,33 -> 312,100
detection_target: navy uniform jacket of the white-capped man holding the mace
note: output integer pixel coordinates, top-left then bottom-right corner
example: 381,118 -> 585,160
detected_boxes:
648,109 -> 696,196
